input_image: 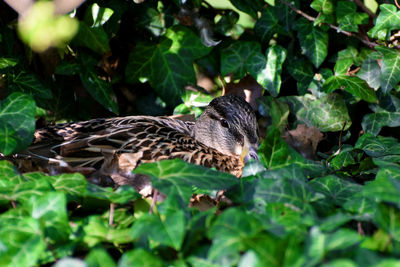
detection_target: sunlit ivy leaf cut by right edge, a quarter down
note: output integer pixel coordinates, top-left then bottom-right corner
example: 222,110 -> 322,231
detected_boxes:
375,46 -> 400,94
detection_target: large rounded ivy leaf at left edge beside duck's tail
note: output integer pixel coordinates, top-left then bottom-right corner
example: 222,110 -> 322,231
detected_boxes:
0,93 -> 36,155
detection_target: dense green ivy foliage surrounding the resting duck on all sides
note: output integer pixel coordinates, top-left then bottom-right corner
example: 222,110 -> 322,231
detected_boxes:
0,0 -> 400,266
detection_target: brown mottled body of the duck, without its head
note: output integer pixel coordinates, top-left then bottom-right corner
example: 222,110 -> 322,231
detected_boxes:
21,116 -> 243,176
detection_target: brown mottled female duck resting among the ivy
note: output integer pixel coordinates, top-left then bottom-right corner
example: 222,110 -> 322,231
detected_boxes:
18,95 -> 258,194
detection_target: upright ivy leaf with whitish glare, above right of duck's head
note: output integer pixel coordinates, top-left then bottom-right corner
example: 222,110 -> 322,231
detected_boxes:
247,45 -> 287,97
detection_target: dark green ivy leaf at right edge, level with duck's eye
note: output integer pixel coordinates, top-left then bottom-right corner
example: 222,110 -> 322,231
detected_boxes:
361,111 -> 400,136
